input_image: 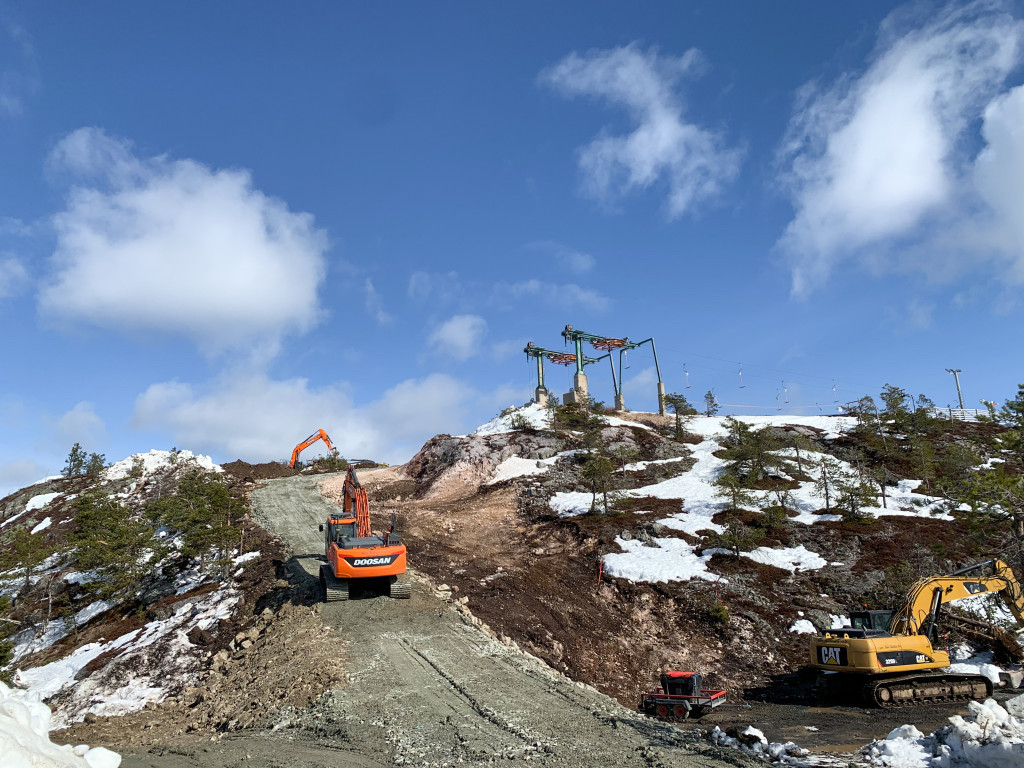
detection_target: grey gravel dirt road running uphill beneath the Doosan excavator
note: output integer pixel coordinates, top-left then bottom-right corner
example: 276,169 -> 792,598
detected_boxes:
157,477 -> 753,768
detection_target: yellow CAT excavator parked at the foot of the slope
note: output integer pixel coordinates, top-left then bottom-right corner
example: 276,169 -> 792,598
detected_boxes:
811,560 -> 1024,707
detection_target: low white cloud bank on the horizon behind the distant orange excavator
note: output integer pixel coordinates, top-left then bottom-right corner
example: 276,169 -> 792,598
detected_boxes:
133,374 -> 477,462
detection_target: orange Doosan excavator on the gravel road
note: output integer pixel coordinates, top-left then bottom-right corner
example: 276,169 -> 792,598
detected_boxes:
319,467 -> 412,602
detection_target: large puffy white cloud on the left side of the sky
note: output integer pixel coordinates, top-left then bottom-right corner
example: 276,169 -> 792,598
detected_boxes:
39,128 -> 328,353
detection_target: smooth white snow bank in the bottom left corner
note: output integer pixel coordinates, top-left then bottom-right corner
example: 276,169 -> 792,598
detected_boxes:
0,683 -> 121,768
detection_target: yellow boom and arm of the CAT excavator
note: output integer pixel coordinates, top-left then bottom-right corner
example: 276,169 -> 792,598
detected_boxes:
889,559 -> 1024,640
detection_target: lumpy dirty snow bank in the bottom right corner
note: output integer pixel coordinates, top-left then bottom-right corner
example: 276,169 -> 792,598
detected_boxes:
863,694 -> 1024,768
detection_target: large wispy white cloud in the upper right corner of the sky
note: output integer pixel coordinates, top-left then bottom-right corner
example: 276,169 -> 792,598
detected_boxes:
779,2 -> 1024,294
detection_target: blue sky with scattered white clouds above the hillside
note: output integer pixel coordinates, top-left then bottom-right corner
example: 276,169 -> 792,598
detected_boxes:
0,1 -> 1024,493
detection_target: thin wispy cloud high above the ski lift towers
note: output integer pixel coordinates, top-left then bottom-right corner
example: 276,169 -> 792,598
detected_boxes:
541,43 -> 741,218
